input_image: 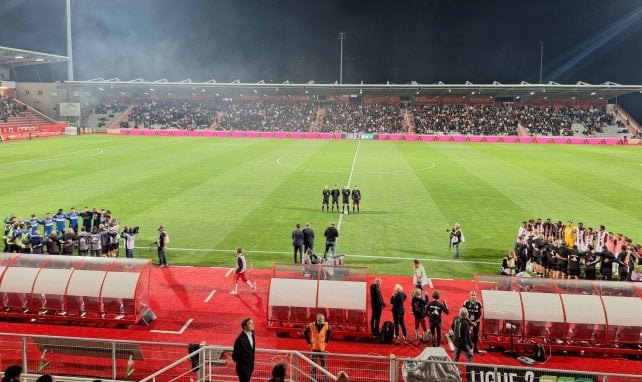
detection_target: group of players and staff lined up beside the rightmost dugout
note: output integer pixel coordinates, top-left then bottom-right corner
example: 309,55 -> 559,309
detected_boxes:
504,219 -> 642,281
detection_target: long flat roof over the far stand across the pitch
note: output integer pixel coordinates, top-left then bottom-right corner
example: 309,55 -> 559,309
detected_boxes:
66,78 -> 642,102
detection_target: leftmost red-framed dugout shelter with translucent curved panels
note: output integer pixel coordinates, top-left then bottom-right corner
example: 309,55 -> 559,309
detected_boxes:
0,253 -> 153,324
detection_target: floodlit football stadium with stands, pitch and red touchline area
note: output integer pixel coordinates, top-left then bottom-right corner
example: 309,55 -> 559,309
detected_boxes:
0,0 -> 642,382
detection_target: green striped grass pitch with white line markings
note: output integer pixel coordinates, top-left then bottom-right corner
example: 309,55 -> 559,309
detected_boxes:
0,136 -> 642,278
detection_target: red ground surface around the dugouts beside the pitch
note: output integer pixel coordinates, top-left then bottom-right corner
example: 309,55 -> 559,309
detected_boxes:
0,266 -> 642,374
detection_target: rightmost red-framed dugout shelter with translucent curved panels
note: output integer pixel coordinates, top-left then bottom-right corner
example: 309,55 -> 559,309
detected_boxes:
475,275 -> 642,355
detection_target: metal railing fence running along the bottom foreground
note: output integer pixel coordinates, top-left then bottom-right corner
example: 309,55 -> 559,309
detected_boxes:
0,334 -> 642,382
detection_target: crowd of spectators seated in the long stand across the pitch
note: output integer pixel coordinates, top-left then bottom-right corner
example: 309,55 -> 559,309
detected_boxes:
97,100 -> 616,136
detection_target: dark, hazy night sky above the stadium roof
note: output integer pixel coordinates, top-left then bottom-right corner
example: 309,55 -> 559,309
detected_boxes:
0,0 -> 642,84
